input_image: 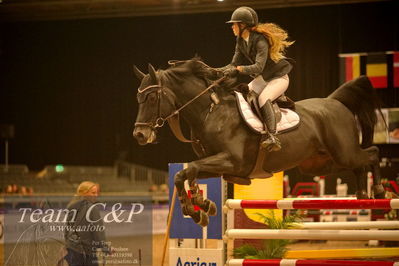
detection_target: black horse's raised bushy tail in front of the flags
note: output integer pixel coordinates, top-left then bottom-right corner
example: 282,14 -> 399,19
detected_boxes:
328,76 -> 381,148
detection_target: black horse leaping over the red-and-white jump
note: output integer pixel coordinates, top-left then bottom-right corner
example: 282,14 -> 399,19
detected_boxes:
133,59 -> 384,226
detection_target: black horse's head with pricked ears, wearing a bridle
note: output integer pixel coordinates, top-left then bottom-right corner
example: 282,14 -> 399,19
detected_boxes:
133,64 -> 175,145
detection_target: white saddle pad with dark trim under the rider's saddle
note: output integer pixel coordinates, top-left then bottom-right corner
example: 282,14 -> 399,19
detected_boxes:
235,91 -> 300,133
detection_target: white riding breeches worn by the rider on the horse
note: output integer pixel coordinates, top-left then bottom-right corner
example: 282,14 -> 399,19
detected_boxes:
248,75 -> 290,107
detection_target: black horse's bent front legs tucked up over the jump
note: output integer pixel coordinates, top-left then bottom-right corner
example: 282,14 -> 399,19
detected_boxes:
175,152 -> 234,226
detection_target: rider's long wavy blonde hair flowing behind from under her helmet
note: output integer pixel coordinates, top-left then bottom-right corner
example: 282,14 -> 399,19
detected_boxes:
252,23 -> 295,63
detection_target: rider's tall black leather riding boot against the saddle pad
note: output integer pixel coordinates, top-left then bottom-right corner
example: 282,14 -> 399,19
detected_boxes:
260,100 -> 281,151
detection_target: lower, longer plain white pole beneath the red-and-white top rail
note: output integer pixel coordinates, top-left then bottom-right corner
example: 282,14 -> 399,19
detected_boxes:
225,229 -> 399,241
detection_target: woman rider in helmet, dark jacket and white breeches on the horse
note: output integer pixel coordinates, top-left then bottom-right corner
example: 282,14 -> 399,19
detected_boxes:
222,6 -> 293,151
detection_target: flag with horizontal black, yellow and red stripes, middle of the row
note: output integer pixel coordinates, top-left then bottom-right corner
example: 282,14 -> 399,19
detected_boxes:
366,53 -> 388,89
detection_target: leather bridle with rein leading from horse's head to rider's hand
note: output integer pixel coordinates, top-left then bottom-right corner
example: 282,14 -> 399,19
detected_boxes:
134,76 -> 226,130
